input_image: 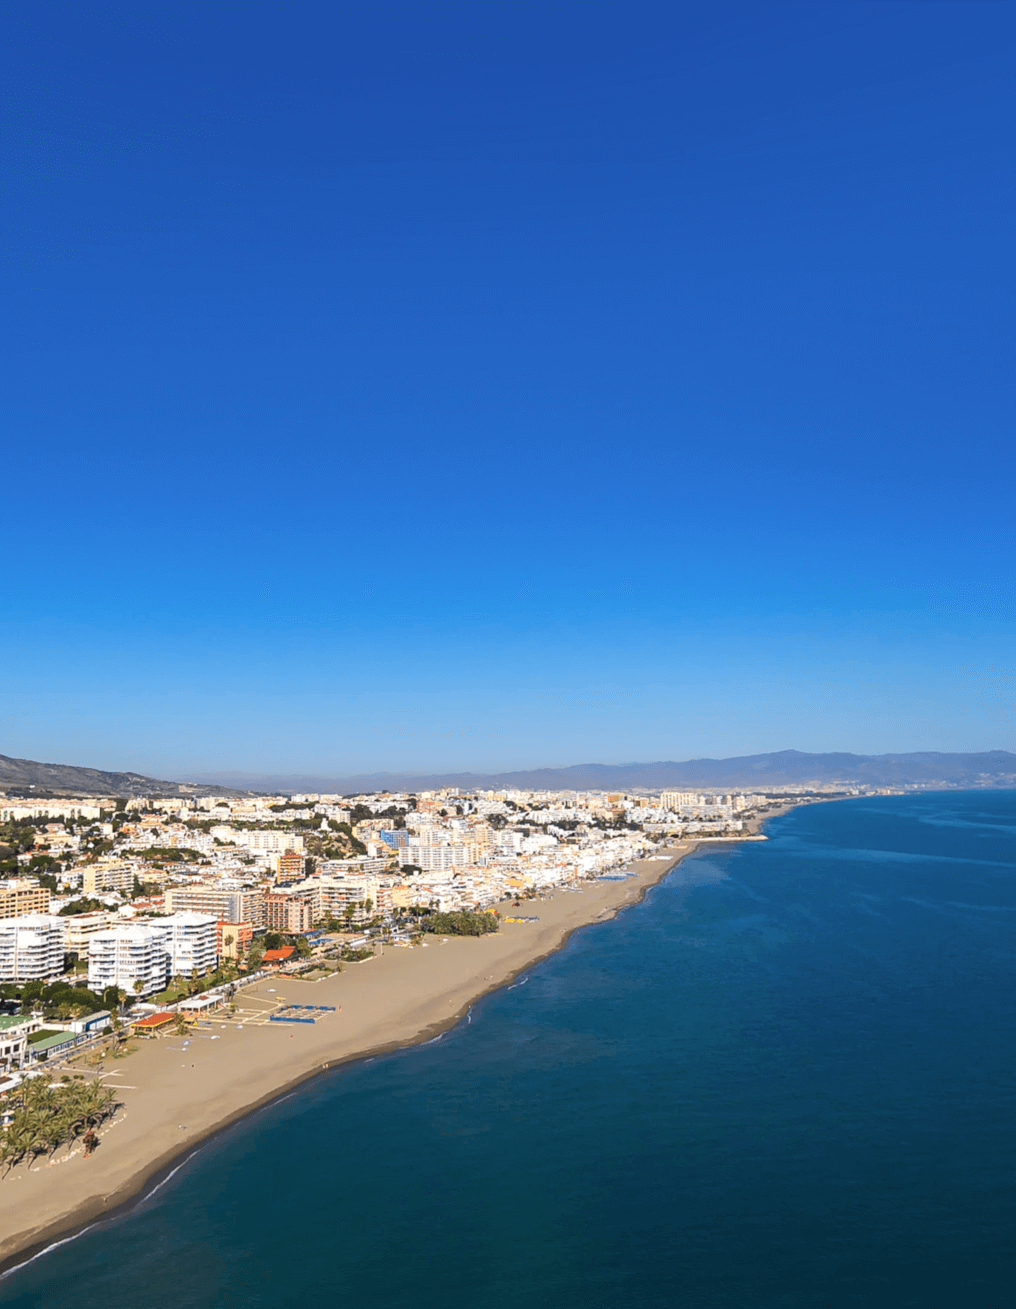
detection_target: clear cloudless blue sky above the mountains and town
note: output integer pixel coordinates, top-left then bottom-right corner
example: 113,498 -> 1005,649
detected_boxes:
0,0 -> 1016,776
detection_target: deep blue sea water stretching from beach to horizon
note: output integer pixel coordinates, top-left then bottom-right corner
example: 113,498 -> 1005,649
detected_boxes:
0,792 -> 1016,1309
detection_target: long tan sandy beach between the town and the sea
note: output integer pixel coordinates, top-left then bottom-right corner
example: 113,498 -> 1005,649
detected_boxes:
0,842 -> 733,1268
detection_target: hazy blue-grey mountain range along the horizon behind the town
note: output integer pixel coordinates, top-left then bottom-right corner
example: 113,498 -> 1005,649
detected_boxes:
180,750 -> 1016,795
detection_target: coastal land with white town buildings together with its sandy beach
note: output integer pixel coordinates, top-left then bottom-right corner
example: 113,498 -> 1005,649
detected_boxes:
0,787 -> 859,1262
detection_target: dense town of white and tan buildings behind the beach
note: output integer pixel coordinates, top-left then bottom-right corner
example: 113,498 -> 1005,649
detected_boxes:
0,774 -> 843,1021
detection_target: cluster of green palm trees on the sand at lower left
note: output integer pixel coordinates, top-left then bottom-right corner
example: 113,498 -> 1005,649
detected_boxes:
0,1073 -> 119,1177
